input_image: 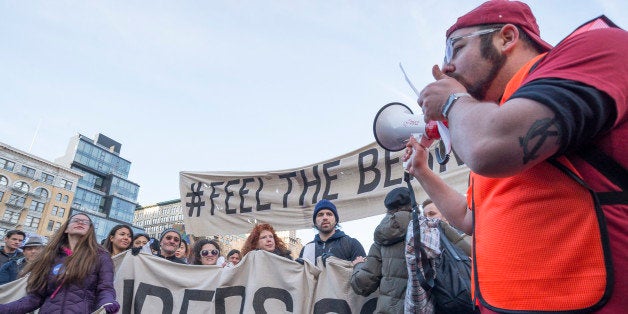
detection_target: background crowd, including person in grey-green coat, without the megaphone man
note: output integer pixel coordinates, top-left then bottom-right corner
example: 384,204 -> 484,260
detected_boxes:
0,193 -> 466,313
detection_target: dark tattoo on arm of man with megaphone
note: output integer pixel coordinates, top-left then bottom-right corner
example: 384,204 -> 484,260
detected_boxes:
519,118 -> 560,165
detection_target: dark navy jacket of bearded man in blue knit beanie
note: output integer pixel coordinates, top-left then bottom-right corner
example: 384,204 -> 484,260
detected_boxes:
299,230 -> 366,264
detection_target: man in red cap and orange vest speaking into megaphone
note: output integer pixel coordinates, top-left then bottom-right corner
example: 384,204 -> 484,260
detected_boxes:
404,0 -> 628,313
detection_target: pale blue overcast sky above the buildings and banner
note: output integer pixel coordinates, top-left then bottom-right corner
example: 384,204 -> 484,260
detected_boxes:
0,0 -> 628,251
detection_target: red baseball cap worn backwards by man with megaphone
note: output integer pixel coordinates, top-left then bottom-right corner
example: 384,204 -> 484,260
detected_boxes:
446,0 -> 552,51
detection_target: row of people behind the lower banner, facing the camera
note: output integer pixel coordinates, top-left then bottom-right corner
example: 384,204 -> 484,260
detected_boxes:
0,200 -> 365,313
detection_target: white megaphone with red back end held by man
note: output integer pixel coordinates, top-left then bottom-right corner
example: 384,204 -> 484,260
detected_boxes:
373,102 -> 441,152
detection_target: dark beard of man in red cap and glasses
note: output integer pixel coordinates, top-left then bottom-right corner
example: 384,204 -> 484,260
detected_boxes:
451,45 -> 506,100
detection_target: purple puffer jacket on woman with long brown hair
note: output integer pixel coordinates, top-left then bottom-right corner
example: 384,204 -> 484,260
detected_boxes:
0,248 -> 116,314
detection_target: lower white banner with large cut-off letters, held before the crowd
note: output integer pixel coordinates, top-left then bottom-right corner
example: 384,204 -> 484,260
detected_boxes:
0,251 -> 378,314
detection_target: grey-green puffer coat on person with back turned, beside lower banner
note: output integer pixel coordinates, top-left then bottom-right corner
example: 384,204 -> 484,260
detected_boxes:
351,211 -> 412,313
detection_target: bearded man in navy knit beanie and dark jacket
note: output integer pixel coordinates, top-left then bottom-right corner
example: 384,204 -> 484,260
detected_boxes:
299,199 -> 366,265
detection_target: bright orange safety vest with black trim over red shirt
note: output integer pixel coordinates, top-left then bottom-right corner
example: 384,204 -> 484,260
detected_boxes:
467,39 -> 612,312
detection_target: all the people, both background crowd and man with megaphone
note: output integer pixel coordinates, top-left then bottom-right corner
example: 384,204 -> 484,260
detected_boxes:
0,0 -> 628,313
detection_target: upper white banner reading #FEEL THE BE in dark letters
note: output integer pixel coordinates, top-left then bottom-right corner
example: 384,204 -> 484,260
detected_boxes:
179,143 -> 469,236
